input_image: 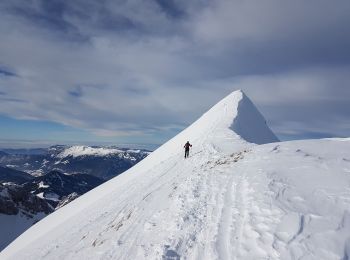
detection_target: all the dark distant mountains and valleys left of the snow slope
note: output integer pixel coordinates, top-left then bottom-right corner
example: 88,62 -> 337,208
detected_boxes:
0,145 -> 150,250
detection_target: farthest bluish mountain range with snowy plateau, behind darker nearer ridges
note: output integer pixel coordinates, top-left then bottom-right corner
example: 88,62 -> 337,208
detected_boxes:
0,145 -> 150,180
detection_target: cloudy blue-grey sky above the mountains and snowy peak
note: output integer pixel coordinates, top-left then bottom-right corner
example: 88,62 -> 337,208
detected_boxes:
0,0 -> 350,147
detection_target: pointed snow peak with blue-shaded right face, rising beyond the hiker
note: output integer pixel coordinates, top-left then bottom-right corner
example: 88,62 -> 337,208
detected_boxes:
160,90 -> 278,154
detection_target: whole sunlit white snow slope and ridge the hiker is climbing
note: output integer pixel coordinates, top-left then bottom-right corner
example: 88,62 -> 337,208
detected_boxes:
0,91 -> 350,259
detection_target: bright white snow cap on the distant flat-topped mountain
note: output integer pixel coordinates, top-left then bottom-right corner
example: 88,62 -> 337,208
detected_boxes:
57,145 -> 123,158
